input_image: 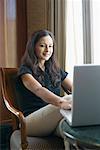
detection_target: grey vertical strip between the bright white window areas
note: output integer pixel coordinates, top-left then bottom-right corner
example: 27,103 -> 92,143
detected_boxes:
82,0 -> 93,63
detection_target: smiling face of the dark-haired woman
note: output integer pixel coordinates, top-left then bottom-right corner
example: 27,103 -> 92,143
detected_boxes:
35,35 -> 53,61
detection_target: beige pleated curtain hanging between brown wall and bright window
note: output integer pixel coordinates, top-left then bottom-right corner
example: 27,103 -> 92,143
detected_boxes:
48,0 -> 66,69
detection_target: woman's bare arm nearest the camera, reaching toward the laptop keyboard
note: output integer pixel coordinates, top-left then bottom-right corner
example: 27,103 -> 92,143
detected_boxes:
21,73 -> 71,109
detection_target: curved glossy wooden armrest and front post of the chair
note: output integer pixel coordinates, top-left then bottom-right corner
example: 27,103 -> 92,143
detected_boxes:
0,68 -> 28,150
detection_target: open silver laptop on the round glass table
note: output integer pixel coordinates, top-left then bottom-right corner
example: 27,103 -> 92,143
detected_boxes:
60,64 -> 100,127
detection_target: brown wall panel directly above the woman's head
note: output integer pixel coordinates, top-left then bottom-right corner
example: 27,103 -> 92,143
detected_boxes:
27,0 -> 48,37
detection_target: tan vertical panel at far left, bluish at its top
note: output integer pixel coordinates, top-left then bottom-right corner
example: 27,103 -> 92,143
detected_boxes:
0,0 -> 16,67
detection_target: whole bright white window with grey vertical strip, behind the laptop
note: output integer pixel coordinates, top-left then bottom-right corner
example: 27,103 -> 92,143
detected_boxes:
66,0 -> 100,79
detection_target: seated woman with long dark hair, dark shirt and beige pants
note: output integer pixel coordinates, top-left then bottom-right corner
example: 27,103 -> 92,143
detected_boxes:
17,30 -> 72,136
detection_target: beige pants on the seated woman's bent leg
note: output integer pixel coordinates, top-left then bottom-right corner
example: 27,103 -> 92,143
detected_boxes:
26,104 -> 63,136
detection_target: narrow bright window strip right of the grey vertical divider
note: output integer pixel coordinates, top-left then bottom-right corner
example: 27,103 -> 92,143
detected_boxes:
91,0 -> 100,64
